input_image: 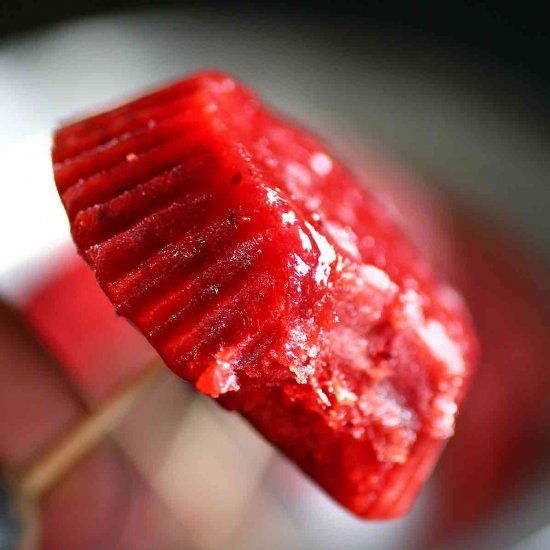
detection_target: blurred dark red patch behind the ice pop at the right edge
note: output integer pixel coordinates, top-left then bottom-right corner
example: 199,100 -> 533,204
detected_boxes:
438,217 -> 550,531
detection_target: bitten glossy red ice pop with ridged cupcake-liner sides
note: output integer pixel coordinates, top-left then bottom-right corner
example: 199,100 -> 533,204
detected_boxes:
53,73 -> 477,518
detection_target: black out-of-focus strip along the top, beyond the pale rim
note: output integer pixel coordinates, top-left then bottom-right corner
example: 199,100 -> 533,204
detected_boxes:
0,0 -> 550,103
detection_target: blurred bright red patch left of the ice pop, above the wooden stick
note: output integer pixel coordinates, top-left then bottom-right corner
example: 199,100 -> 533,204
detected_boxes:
22,253 -> 154,400
